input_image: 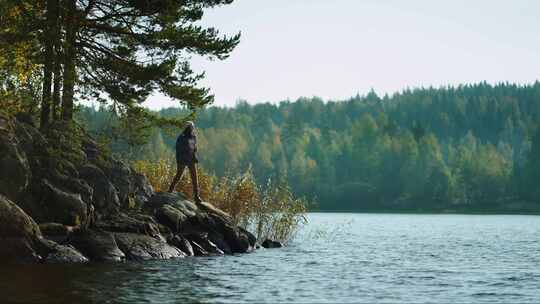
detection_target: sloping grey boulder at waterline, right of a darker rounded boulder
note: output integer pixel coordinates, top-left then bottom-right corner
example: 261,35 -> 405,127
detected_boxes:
114,233 -> 186,261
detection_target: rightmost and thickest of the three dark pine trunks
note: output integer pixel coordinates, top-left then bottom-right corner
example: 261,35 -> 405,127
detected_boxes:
62,0 -> 77,120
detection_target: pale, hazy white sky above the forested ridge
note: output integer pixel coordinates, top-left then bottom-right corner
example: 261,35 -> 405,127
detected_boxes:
145,0 -> 540,109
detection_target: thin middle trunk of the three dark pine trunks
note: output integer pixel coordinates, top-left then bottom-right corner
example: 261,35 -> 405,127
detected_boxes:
49,0 -> 62,120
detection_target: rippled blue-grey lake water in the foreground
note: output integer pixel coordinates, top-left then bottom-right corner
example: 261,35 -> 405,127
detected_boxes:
0,213 -> 540,303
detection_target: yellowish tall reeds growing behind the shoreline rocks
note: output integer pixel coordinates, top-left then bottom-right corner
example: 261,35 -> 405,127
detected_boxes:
134,159 -> 308,243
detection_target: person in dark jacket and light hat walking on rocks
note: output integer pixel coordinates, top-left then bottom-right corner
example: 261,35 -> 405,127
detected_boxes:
169,121 -> 201,203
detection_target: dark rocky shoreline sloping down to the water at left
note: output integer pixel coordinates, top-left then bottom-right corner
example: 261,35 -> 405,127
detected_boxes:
0,116 -> 270,263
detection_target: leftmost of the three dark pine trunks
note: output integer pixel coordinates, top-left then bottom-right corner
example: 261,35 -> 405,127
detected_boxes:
40,0 -> 55,128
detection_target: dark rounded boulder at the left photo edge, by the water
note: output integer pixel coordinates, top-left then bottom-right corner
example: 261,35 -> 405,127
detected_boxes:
0,194 -> 41,262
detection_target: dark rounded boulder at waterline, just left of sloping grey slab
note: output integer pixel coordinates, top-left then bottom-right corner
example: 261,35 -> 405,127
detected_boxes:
68,230 -> 126,262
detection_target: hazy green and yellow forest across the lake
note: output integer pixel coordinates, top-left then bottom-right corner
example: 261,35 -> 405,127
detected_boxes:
77,82 -> 540,213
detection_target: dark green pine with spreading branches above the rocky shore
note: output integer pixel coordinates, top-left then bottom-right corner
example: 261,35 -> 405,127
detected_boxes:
0,0 -> 240,125
